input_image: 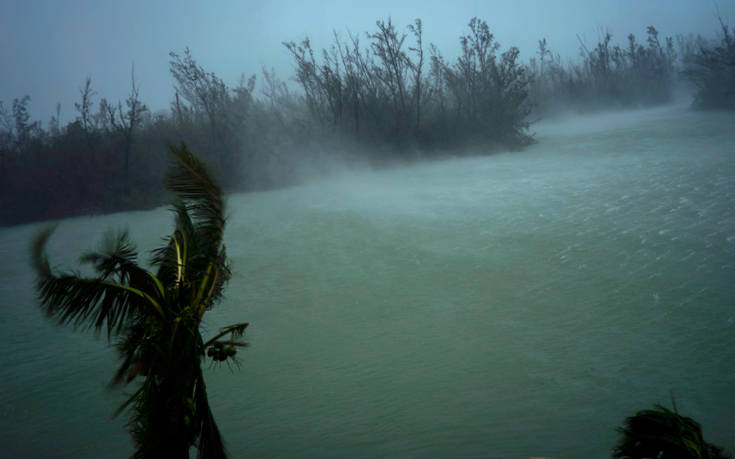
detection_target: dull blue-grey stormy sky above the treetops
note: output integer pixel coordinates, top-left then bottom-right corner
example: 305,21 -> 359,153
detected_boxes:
0,0 -> 735,126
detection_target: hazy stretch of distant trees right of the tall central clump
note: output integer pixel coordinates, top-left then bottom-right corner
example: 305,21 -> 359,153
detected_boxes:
528,18 -> 735,115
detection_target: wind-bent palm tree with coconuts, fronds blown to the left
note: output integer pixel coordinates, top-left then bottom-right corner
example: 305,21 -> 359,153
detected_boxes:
32,142 -> 248,458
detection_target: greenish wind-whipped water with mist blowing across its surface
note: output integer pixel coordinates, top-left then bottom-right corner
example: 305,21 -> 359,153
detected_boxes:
0,106 -> 735,458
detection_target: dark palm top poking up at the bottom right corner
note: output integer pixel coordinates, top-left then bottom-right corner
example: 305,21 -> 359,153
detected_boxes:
613,403 -> 730,459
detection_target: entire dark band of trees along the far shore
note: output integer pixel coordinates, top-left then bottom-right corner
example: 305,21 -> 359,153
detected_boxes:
0,18 -> 735,225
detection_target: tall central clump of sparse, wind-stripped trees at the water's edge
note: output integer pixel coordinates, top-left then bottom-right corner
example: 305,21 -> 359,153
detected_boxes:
284,18 -> 531,150
